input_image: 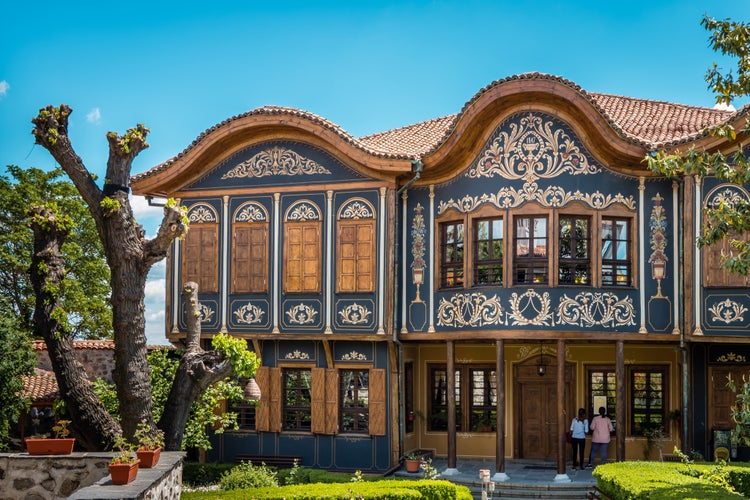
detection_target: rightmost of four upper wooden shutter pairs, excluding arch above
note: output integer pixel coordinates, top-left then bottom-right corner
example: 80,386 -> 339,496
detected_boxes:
336,220 -> 375,293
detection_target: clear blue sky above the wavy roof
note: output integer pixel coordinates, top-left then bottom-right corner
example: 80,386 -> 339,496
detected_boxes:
0,0 -> 750,343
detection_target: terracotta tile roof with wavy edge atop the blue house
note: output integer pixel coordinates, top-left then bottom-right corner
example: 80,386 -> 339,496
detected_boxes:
131,73 -> 747,181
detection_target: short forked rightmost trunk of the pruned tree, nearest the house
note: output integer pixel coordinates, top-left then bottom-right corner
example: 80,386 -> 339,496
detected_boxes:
158,281 -> 232,450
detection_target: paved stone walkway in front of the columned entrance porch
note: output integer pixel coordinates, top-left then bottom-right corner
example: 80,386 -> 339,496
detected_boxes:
395,458 -> 596,486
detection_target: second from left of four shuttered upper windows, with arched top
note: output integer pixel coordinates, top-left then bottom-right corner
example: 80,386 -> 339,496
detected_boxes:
232,202 -> 268,293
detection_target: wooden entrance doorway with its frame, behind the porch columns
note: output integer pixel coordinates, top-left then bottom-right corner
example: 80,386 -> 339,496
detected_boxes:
513,355 -> 575,460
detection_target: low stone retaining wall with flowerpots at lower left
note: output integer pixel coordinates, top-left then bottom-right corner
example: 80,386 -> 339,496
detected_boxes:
0,452 -> 185,500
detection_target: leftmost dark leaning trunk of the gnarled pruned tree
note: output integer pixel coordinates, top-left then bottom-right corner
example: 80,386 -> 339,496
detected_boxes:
30,207 -> 120,451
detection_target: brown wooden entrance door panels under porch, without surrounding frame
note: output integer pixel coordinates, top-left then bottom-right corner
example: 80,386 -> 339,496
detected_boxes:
520,381 -> 557,459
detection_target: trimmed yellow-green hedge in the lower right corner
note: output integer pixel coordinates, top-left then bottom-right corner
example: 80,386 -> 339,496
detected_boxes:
593,462 -> 750,500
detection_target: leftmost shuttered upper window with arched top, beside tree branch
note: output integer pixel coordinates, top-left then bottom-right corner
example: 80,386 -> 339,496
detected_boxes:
182,203 -> 219,293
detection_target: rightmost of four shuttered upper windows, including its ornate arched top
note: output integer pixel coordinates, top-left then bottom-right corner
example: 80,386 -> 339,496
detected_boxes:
336,198 -> 376,293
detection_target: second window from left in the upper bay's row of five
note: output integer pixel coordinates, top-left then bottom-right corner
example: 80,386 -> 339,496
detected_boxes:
474,217 -> 503,286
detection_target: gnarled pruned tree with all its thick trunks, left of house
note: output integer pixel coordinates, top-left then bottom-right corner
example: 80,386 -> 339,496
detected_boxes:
32,104 -> 257,450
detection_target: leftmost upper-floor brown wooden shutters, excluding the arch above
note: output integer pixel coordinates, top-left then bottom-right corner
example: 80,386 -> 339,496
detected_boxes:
182,224 -> 219,293
